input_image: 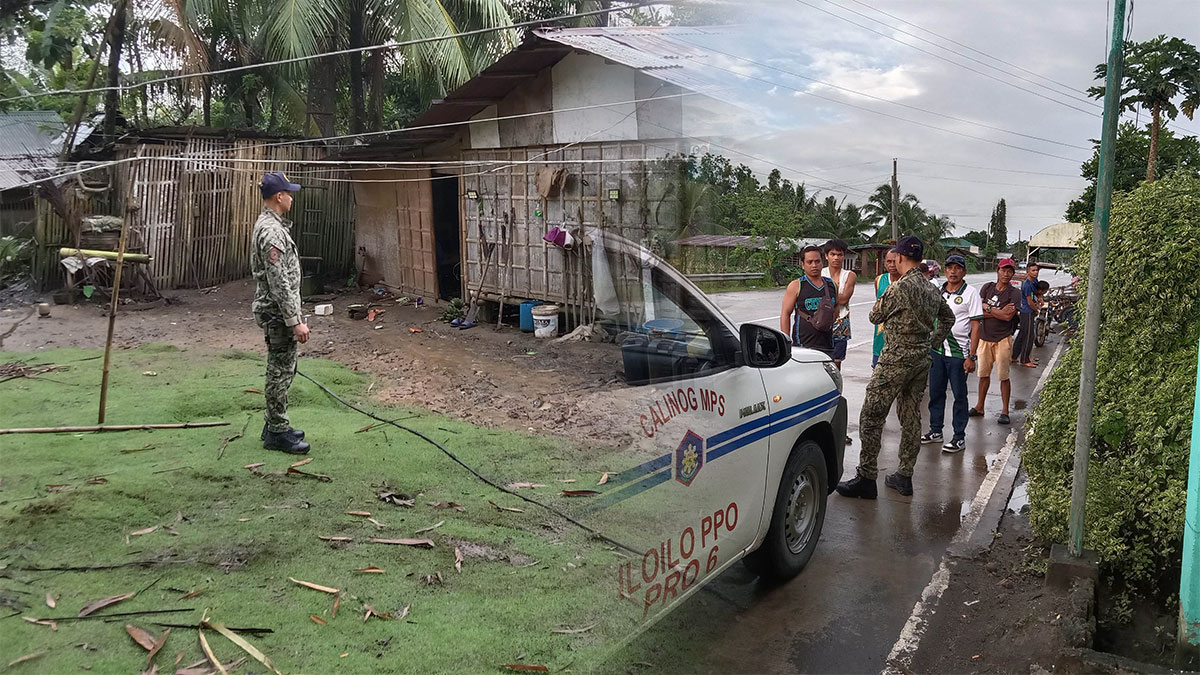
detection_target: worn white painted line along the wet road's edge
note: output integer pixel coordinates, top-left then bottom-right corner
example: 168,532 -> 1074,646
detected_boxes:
883,341 -> 1067,675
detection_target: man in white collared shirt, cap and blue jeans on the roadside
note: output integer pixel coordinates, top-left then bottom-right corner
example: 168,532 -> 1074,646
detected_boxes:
920,256 -> 983,453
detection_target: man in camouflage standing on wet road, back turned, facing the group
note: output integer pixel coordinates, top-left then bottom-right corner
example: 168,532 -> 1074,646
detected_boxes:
838,237 -> 954,500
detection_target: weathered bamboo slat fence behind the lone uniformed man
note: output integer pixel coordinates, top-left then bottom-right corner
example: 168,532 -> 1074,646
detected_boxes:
38,138 -> 354,289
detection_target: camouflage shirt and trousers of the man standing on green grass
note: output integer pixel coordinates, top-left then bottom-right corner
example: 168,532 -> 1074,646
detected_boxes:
250,209 -> 300,432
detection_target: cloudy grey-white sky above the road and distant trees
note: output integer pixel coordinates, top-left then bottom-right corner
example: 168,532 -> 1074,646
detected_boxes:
676,0 -> 1200,239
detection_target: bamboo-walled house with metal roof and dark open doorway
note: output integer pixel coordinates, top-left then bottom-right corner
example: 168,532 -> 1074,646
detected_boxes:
341,26 -> 745,307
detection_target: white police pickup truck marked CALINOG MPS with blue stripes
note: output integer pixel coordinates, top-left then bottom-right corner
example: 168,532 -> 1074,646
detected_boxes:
568,231 -> 846,620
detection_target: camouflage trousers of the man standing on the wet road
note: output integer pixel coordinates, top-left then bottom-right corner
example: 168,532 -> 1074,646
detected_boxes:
858,345 -> 931,480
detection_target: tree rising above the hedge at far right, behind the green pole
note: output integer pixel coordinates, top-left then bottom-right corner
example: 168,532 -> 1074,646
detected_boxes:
1087,35 -> 1200,181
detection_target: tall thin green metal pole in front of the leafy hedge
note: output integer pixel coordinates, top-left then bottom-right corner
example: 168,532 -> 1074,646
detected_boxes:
1068,0 -> 1126,557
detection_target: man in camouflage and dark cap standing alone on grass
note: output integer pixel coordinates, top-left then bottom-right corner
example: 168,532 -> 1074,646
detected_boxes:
250,173 -> 308,455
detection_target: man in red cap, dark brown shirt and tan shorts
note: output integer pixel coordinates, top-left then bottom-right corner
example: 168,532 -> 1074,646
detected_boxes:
967,258 -> 1021,424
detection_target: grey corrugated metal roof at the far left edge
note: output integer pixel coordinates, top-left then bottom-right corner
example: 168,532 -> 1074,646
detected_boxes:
0,110 -> 66,190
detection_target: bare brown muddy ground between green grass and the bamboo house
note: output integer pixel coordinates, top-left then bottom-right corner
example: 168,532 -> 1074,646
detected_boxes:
0,280 -> 636,447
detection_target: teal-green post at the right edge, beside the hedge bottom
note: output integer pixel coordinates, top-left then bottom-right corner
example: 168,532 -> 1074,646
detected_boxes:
1178,333 -> 1200,667
